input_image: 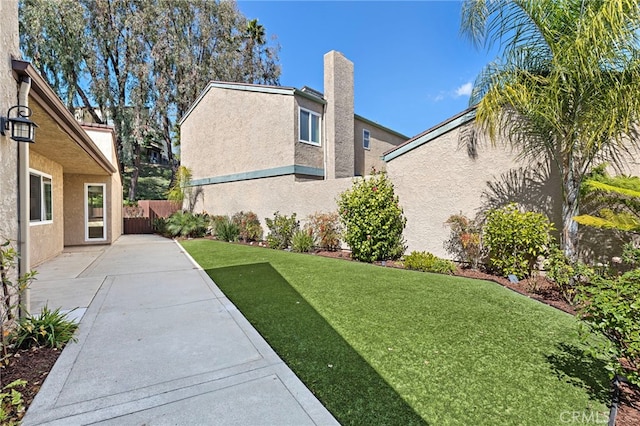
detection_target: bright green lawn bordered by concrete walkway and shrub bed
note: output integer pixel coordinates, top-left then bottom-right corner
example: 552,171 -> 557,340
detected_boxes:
182,240 -> 608,425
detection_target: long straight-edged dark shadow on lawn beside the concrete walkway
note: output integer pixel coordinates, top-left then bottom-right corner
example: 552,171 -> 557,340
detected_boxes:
206,263 -> 426,425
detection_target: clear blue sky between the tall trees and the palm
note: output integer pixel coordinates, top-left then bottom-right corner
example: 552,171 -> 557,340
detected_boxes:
238,0 -> 497,136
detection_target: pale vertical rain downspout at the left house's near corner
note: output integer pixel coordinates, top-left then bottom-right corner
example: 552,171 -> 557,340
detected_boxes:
18,76 -> 31,318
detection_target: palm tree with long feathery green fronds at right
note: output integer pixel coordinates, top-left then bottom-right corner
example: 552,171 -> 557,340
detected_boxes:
462,0 -> 640,259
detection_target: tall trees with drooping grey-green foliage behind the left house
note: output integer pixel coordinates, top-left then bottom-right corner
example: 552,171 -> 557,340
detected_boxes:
20,0 -> 280,200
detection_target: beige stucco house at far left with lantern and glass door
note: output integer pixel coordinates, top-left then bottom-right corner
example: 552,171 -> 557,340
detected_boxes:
0,1 -> 122,312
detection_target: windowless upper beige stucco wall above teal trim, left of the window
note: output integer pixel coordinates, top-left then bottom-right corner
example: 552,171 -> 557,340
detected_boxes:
180,87 -> 295,179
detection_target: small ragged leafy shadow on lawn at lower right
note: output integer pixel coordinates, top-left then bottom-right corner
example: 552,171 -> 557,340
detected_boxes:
547,343 -> 611,405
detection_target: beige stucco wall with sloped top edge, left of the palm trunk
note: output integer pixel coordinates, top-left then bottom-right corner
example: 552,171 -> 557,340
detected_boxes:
387,121 -> 551,258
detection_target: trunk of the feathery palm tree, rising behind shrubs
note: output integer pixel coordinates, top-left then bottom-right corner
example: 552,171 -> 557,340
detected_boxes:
560,165 -> 580,261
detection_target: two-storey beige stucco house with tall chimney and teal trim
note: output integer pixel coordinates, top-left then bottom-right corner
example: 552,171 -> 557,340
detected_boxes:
180,51 -> 408,220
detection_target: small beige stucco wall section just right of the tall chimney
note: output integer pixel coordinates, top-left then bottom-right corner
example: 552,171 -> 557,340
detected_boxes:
353,117 -> 407,176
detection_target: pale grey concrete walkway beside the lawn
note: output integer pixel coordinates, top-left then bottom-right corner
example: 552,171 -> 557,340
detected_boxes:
24,235 -> 337,425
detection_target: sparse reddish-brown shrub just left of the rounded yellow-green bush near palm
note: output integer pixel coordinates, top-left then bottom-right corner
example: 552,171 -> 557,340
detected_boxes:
444,213 -> 484,269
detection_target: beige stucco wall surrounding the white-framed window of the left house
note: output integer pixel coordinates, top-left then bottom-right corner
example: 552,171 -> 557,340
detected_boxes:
29,150 -> 65,266
